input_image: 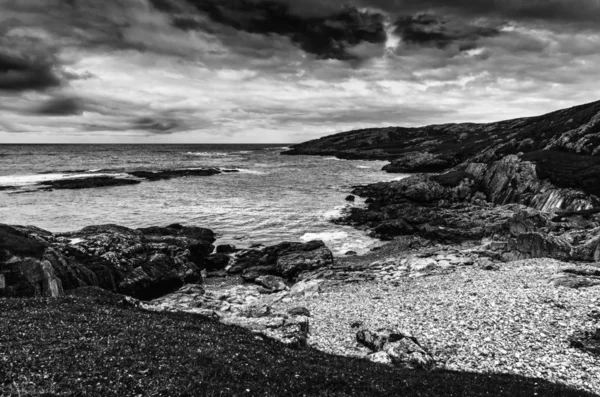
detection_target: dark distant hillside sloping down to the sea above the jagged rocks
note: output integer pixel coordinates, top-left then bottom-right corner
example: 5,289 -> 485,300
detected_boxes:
285,101 -> 600,195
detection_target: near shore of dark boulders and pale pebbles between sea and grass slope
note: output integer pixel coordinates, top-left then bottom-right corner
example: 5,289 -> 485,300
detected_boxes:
0,215 -> 600,392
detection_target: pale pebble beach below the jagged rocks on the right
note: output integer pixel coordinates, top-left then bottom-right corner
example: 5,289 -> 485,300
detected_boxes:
274,259 -> 600,394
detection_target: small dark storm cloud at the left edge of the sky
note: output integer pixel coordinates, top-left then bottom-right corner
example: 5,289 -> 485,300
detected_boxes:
0,48 -> 61,91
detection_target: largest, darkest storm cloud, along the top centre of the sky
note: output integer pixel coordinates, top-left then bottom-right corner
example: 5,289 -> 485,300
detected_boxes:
151,0 -> 386,60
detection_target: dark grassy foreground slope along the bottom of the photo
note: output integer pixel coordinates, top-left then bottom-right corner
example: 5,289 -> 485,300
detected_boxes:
0,288 -> 592,397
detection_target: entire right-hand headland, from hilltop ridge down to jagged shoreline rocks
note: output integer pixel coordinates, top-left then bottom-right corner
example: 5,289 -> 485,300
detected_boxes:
286,102 -> 600,262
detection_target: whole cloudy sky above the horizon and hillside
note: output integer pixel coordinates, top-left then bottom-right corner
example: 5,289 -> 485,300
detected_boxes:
0,0 -> 600,144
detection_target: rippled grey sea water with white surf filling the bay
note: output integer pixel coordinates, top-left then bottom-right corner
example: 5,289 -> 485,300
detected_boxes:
0,145 -> 402,255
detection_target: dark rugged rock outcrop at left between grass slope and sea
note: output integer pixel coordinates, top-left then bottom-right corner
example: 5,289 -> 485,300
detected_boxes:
0,224 -> 215,299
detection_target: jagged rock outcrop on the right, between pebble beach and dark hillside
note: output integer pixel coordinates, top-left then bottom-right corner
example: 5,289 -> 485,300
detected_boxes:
340,164 -> 600,262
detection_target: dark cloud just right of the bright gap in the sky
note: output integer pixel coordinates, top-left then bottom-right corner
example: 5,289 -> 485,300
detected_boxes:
395,14 -> 501,51
